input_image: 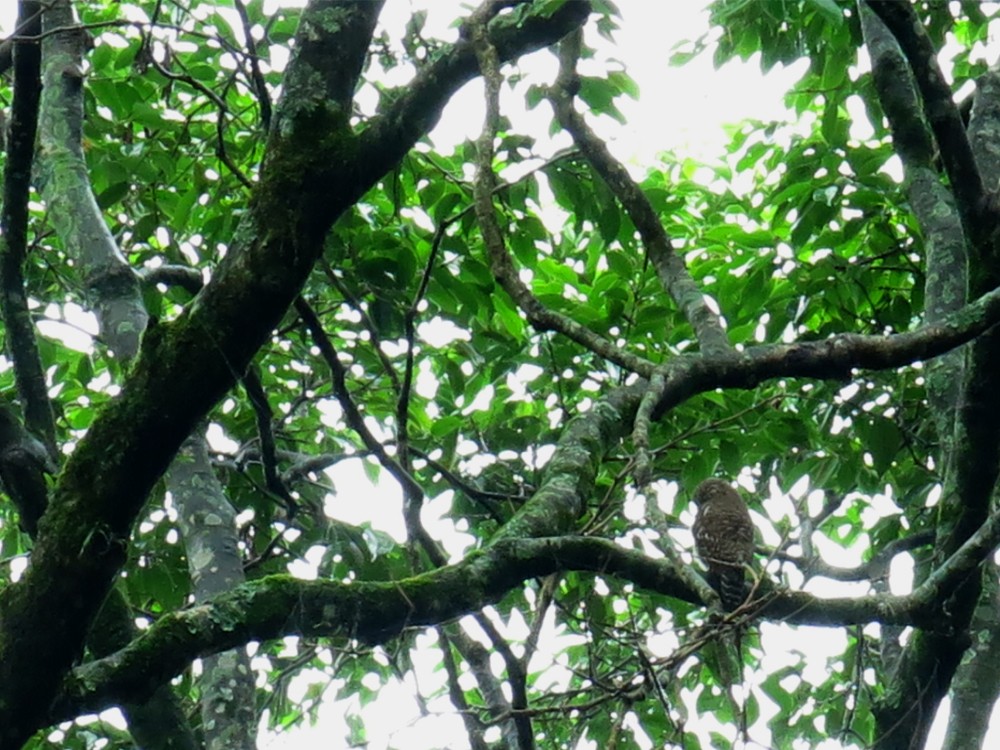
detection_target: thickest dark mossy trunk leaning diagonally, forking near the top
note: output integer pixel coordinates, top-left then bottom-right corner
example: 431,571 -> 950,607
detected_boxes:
0,0 -> 589,746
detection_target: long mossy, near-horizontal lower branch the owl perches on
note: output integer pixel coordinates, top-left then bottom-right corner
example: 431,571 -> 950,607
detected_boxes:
51,506 -> 1000,720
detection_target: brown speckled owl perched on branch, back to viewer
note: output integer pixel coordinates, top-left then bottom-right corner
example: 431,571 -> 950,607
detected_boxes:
692,479 -> 753,612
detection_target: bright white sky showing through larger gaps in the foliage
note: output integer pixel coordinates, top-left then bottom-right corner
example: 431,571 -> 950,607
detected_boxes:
0,0 -> 1000,750
